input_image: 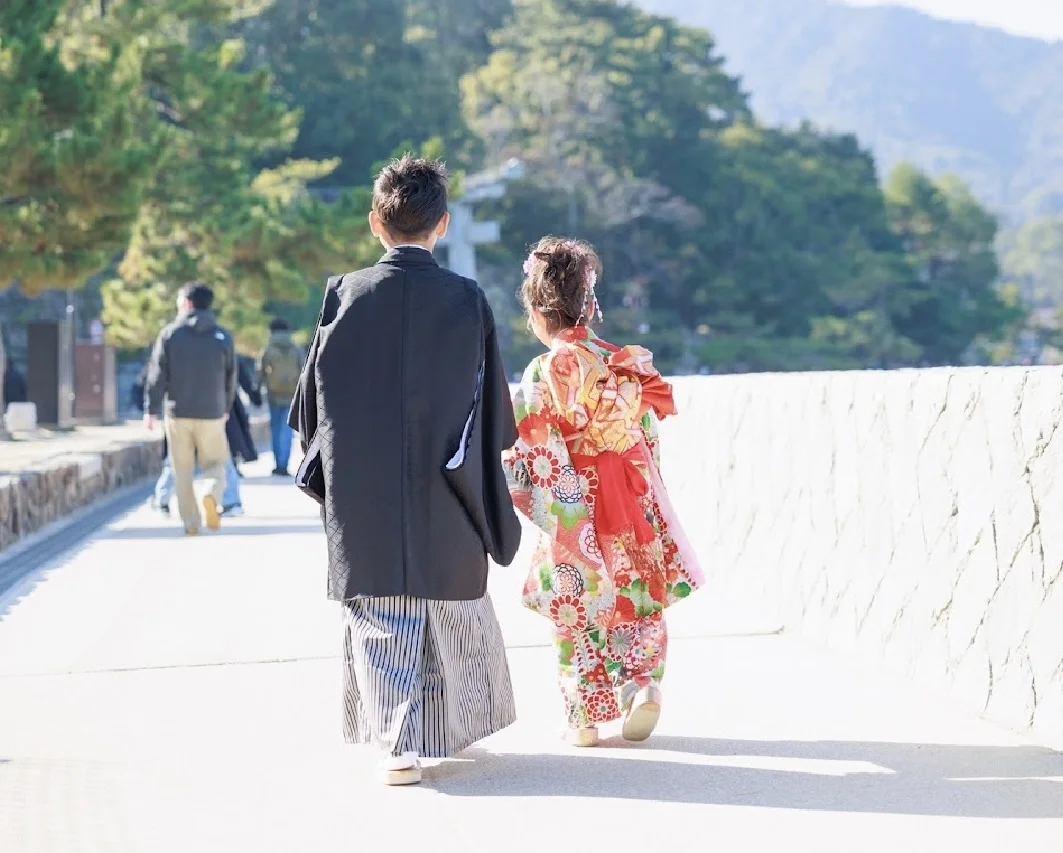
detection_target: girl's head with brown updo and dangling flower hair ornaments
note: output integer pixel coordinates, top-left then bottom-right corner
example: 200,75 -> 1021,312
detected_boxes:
521,237 -> 602,335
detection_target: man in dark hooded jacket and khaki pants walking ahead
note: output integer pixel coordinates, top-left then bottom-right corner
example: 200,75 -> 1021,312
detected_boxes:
145,282 -> 236,536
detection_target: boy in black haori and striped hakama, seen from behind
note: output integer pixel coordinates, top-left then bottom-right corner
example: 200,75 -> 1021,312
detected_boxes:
289,156 -> 521,785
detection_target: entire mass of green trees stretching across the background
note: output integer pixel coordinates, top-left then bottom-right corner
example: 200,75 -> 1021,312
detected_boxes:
0,0 -> 1020,370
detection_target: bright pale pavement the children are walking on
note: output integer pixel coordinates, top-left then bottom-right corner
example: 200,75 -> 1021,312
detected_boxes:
0,461 -> 1063,853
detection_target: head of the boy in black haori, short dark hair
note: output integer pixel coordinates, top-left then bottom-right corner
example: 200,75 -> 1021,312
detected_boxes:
373,154 -> 448,238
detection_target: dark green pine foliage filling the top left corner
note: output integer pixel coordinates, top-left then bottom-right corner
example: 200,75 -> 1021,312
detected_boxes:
0,0 -> 157,294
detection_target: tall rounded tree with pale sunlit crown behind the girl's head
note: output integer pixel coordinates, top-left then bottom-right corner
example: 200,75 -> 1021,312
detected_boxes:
465,0 -> 747,359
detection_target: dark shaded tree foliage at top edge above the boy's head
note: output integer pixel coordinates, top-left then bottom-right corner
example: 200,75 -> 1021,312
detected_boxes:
239,0 -> 501,186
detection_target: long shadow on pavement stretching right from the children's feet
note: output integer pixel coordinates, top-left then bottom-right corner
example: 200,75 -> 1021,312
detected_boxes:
425,737 -> 1063,819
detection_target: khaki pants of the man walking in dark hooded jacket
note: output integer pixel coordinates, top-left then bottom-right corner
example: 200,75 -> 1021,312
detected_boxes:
166,417 -> 229,533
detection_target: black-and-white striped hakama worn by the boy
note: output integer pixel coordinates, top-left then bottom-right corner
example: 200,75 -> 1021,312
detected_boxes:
342,596 -> 517,758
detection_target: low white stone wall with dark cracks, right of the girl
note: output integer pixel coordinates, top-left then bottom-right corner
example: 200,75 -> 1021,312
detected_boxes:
662,368 -> 1063,747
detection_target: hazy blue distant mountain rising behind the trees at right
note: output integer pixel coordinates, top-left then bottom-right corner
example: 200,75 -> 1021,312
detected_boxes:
637,0 -> 1063,220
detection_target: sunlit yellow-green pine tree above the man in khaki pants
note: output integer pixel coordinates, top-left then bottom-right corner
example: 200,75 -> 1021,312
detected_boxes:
55,0 -> 357,349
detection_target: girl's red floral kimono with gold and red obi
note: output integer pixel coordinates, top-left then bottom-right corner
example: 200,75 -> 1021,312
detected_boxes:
503,327 -> 701,729
